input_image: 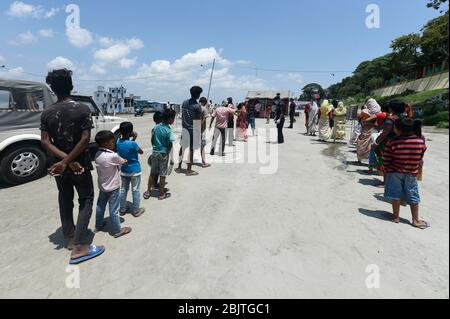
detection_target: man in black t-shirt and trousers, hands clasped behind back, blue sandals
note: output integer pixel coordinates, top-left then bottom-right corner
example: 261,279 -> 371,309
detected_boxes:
40,69 -> 105,265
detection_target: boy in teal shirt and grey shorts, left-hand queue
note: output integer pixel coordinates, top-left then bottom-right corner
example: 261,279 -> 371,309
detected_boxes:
149,109 -> 176,200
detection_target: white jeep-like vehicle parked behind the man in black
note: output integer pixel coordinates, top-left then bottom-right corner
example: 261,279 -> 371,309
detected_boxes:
0,79 -> 124,185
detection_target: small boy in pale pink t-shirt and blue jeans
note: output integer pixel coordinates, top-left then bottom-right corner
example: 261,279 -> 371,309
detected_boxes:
95,131 -> 131,238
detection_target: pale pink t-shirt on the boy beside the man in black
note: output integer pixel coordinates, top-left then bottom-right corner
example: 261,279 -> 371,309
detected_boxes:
95,148 -> 126,193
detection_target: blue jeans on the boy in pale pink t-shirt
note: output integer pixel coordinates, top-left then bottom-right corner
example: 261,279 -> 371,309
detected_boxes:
95,189 -> 121,234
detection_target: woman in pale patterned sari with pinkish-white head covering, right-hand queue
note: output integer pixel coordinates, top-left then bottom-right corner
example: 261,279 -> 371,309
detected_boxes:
356,99 -> 381,163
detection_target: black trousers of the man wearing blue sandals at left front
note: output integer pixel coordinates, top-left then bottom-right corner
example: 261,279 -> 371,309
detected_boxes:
56,171 -> 94,245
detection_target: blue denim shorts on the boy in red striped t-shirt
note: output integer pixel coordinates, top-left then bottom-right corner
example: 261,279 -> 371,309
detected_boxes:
384,173 -> 420,205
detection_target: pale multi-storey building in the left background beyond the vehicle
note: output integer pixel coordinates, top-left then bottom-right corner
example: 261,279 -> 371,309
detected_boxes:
93,86 -> 136,114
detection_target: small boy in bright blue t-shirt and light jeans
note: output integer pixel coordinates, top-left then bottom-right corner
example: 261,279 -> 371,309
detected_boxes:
117,122 -> 145,217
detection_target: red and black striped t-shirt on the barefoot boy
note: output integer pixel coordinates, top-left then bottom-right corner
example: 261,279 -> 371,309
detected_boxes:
384,135 -> 427,175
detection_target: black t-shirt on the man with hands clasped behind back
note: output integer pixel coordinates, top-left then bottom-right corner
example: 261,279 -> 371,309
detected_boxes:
40,101 -> 93,170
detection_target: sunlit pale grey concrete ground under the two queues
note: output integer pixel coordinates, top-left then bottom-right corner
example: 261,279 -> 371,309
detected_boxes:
0,116 -> 449,298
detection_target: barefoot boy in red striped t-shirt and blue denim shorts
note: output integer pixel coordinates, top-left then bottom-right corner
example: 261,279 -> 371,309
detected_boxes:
384,118 -> 429,229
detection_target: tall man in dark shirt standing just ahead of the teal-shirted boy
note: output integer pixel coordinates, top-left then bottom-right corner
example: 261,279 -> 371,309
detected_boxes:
176,86 -> 203,176
